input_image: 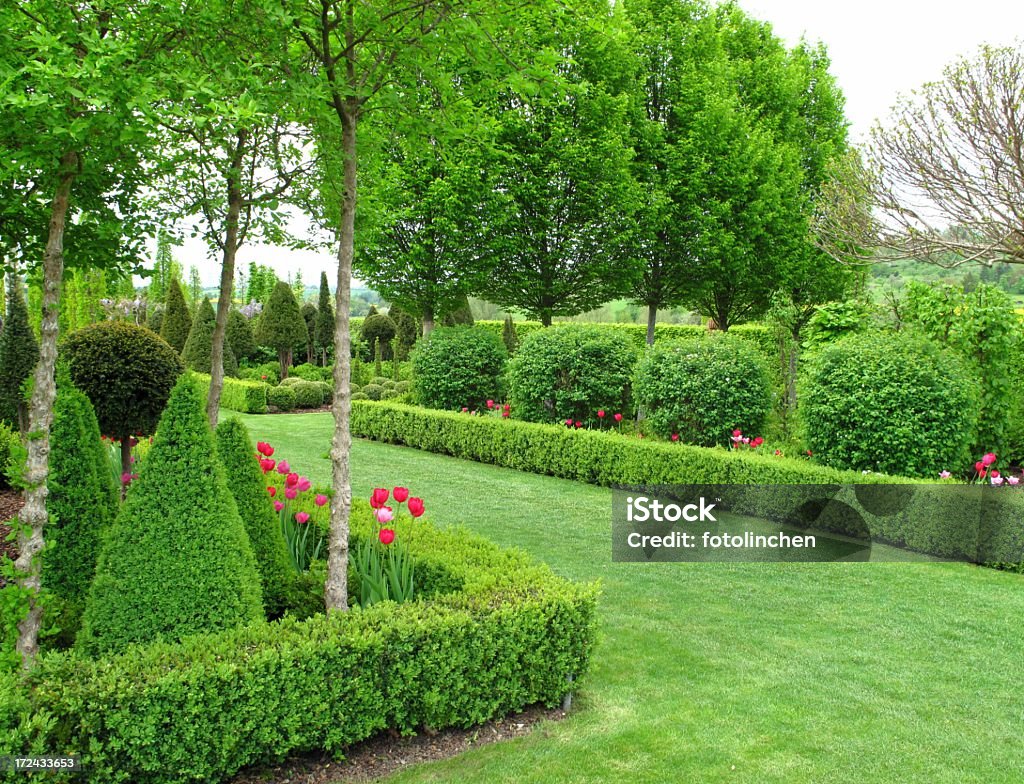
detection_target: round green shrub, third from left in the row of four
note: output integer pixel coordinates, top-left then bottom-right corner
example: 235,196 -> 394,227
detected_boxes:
633,334 -> 771,446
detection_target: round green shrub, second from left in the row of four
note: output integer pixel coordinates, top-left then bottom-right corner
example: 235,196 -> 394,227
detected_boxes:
505,324 -> 636,422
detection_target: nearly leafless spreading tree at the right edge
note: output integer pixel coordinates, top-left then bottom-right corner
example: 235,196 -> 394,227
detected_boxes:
815,45 -> 1024,266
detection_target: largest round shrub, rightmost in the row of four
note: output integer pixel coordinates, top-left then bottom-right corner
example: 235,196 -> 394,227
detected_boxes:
800,334 -> 978,477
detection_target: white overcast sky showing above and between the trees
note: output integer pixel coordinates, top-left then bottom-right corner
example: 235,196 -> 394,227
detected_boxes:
174,0 -> 1024,288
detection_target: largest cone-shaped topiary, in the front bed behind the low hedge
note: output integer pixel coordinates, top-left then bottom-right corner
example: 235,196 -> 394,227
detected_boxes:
77,375 -> 263,654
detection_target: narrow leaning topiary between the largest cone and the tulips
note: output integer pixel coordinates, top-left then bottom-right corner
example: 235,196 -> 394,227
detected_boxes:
216,419 -> 295,616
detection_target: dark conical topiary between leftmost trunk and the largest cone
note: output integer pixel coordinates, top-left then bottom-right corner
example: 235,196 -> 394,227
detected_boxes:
42,373 -> 118,644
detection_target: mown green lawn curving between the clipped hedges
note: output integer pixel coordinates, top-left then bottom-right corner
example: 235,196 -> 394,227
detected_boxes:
235,415 -> 1024,784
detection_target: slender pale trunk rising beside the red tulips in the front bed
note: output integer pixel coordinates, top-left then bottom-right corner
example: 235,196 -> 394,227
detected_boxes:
324,99 -> 358,612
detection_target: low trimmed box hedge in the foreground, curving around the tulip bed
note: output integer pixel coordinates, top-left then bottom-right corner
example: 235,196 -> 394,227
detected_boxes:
0,502 -> 597,784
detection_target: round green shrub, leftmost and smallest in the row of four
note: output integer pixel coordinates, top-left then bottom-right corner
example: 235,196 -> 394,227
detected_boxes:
413,326 -> 508,409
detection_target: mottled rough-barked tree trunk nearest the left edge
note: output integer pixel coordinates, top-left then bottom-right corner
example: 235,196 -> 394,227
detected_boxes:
14,150 -> 79,669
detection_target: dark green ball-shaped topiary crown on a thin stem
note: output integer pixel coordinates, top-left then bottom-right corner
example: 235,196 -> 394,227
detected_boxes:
60,319 -> 184,440
